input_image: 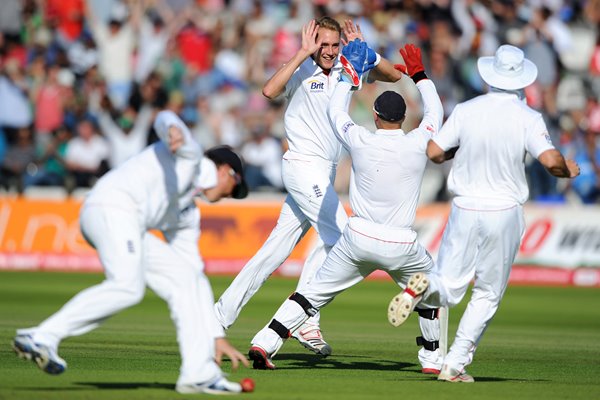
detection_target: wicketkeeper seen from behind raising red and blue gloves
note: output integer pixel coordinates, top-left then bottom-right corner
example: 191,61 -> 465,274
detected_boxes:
249,39 -> 443,369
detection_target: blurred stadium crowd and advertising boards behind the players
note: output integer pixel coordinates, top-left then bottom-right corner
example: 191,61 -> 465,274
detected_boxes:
0,0 -> 600,287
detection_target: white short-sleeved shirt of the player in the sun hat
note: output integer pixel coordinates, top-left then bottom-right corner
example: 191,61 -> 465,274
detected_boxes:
433,92 -> 554,208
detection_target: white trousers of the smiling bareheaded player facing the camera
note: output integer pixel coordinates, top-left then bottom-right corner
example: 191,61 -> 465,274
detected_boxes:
215,152 -> 348,328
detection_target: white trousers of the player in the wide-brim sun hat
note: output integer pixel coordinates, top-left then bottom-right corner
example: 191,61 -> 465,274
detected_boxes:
438,198 -> 525,371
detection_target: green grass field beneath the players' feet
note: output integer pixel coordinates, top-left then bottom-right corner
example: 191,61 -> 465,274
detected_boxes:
0,272 -> 600,400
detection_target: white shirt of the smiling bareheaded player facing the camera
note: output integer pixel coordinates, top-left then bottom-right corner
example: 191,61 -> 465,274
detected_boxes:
284,58 -> 342,163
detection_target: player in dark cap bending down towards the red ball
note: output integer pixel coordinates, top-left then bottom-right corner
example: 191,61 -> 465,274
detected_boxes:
13,111 -> 253,394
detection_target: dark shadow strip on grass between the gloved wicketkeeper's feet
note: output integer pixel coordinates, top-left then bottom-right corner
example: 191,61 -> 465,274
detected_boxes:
275,353 -> 415,371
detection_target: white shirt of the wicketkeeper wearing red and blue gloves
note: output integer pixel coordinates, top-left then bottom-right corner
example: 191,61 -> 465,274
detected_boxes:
329,79 -> 443,229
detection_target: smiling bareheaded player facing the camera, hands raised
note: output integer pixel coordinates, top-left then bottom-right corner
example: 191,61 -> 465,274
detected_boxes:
215,17 -> 402,356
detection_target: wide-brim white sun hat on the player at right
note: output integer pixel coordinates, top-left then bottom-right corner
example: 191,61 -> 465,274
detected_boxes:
477,44 -> 537,90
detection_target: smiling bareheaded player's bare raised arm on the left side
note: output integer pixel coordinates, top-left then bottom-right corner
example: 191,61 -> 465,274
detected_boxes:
262,19 -> 321,99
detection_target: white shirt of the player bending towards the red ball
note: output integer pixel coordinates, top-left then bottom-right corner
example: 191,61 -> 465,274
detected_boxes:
86,111 -> 217,230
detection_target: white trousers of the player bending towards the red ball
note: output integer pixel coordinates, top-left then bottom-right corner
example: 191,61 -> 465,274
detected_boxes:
31,204 -> 222,383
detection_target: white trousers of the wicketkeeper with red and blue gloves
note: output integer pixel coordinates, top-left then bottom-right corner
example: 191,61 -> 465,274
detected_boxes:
252,217 -> 434,354
